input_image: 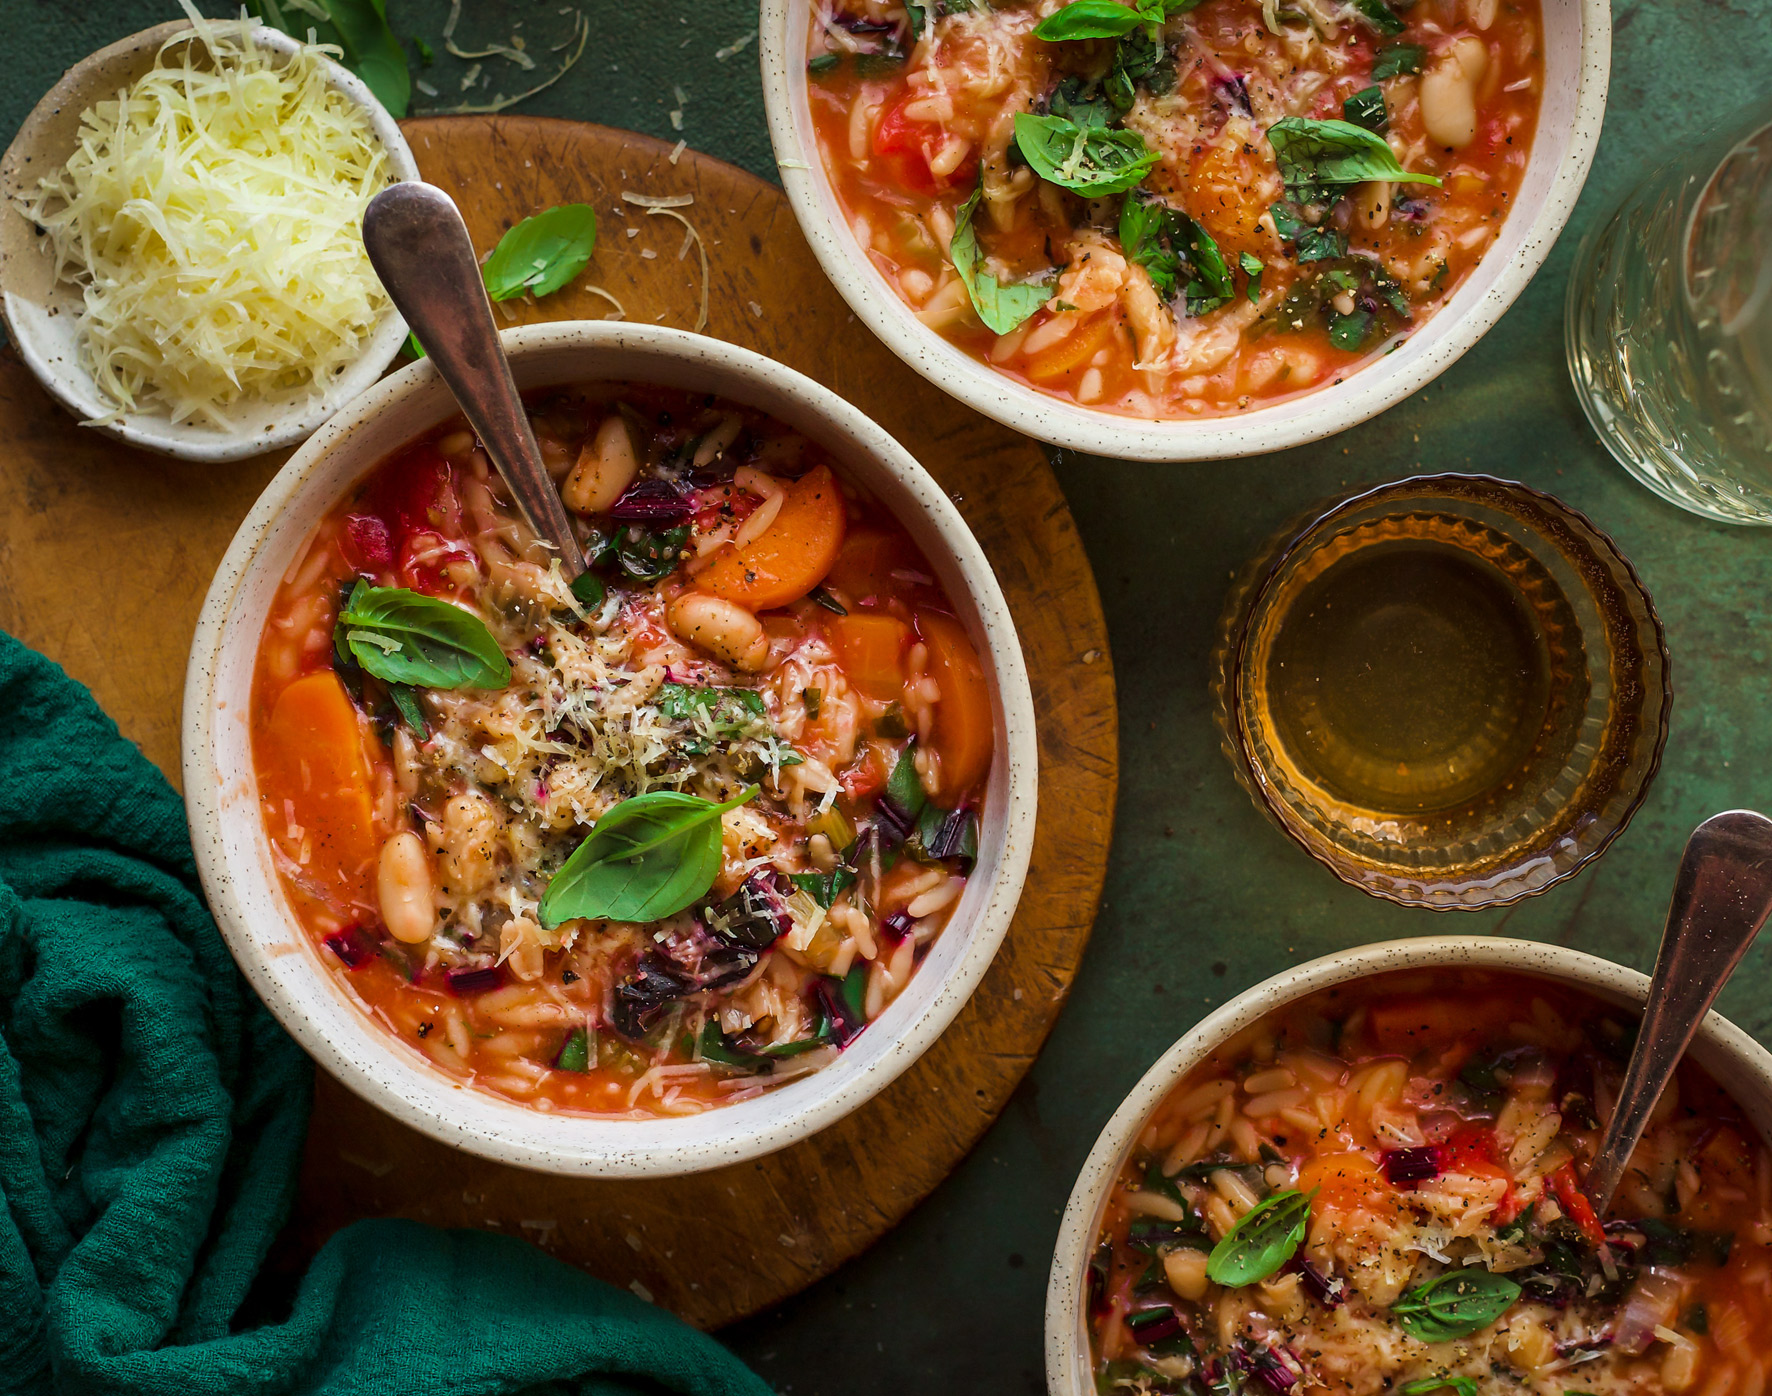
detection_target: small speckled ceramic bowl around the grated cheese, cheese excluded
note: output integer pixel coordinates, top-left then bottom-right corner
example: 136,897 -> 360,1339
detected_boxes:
0,19 -> 418,462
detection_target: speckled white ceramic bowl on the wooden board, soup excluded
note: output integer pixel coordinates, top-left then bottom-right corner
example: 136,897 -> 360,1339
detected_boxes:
183,321 -> 1037,1176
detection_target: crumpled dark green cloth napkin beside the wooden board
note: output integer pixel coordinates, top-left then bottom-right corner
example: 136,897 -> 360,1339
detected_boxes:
0,634 -> 769,1396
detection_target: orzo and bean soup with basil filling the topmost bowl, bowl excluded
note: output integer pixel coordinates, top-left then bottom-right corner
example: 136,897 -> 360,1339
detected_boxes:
808,0 -> 1543,418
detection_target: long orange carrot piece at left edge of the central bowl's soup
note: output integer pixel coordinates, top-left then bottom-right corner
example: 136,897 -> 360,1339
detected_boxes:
259,670 -> 379,893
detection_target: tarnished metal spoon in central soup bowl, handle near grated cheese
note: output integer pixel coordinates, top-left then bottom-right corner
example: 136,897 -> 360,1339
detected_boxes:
363,181 -> 585,581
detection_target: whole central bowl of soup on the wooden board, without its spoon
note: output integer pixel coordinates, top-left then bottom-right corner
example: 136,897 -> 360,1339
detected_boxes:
184,322 -> 1035,1175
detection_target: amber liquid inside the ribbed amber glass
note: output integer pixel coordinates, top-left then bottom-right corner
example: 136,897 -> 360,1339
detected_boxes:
1255,516 -> 1574,817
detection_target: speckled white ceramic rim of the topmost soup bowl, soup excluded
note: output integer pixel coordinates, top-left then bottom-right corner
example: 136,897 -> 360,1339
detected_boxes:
758,0 -> 1613,461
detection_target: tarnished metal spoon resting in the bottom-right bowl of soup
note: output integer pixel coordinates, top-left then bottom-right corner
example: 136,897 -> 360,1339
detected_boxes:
1588,810 -> 1772,1217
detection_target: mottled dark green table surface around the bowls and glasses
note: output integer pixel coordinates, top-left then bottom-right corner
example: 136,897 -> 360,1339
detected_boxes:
0,0 -> 1772,1396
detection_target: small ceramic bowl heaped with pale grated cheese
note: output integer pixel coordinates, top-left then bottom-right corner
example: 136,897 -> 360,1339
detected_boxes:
0,19 -> 418,462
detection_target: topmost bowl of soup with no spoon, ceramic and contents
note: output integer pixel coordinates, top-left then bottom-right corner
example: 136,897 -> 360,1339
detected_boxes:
760,0 -> 1611,461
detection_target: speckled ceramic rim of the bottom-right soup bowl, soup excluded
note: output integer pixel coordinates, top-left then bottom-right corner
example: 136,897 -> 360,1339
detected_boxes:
1045,935 -> 1772,1396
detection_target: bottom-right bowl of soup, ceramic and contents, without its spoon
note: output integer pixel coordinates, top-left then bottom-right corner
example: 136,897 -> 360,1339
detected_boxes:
1045,937 -> 1772,1396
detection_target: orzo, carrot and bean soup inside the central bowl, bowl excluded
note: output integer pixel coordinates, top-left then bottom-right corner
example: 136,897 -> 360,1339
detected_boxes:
252,384 -> 992,1114
